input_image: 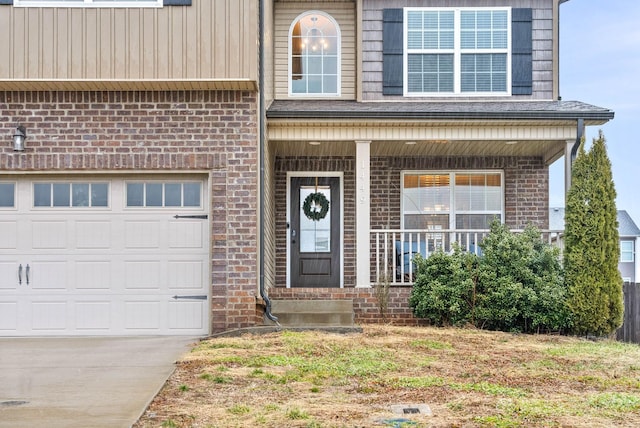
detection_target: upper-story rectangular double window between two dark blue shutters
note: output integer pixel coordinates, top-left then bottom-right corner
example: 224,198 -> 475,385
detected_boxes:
403,8 -> 511,96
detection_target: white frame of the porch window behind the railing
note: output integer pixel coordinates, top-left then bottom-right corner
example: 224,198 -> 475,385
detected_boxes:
400,169 -> 505,230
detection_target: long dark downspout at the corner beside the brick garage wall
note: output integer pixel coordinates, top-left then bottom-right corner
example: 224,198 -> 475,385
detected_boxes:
258,0 -> 280,326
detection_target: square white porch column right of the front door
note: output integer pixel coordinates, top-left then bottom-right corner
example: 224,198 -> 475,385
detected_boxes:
355,141 -> 371,288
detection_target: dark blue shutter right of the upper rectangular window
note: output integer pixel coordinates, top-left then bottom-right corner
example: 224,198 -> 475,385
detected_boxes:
511,9 -> 533,95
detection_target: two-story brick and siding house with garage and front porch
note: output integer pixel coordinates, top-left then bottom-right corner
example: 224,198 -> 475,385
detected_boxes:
0,0 -> 613,335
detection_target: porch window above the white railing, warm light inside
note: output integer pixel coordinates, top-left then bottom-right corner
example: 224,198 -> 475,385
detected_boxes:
402,171 -> 504,230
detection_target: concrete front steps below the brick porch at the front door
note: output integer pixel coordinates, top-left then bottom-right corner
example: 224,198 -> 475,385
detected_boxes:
267,300 -> 355,327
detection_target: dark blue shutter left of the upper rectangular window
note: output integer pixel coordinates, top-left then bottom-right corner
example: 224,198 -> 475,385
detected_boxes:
382,9 -> 404,95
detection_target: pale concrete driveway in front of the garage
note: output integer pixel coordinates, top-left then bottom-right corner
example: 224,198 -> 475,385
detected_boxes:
0,336 -> 198,428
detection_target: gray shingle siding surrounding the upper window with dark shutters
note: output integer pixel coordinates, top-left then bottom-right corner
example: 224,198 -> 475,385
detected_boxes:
362,0 -> 555,100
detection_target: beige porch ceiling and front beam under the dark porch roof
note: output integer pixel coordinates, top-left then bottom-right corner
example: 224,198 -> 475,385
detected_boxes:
268,119 -> 577,163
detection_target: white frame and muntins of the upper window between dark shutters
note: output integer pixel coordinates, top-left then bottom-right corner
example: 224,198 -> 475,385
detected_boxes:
402,7 -> 512,97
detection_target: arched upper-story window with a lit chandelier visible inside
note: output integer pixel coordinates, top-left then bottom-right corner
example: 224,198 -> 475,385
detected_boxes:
289,11 -> 340,96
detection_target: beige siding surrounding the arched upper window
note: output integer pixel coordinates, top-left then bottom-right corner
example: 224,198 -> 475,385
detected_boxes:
274,0 -> 356,100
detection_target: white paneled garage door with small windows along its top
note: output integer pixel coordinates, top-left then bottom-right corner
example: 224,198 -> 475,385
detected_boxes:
0,176 -> 209,336
